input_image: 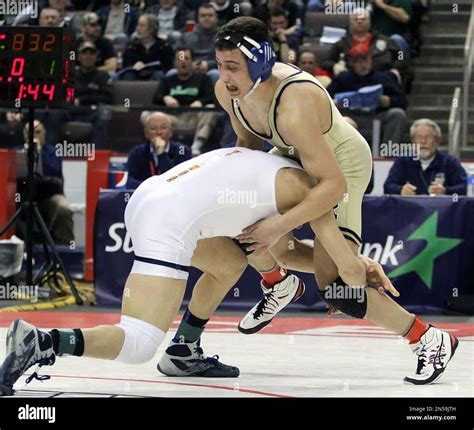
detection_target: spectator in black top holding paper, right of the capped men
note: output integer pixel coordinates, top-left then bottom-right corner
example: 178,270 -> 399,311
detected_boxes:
122,14 -> 173,80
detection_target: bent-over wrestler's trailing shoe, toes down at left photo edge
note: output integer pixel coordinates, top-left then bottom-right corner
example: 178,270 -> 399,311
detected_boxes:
0,320 -> 56,396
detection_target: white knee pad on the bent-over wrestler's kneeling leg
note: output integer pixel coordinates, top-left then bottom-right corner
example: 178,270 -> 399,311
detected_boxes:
115,315 -> 166,364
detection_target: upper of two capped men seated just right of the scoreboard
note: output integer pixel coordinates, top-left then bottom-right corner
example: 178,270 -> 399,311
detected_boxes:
78,12 -> 117,73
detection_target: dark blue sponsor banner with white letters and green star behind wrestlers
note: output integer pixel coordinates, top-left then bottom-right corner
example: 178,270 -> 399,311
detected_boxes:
94,190 -> 474,312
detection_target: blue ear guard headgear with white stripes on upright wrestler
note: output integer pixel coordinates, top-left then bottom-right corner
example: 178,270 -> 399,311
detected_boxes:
220,34 -> 276,85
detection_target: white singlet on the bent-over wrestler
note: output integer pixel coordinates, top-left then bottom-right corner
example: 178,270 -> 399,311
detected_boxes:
125,148 -> 301,279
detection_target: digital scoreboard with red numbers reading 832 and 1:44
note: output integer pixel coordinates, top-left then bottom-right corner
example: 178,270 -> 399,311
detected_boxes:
0,27 -> 76,108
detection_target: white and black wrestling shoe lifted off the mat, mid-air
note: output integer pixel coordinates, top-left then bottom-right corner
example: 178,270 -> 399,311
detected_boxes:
238,274 -> 305,334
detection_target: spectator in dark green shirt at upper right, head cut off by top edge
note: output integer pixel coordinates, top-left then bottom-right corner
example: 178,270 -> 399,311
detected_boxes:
370,0 -> 412,60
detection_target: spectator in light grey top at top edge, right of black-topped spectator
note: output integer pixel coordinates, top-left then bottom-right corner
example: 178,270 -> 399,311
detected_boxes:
147,0 -> 193,45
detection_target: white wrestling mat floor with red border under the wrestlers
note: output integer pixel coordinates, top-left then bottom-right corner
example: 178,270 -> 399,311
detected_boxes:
0,307 -> 474,397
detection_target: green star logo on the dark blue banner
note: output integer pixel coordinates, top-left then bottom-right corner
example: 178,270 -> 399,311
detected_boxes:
387,211 -> 463,289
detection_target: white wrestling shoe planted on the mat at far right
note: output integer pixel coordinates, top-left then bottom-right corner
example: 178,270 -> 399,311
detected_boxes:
403,326 -> 459,385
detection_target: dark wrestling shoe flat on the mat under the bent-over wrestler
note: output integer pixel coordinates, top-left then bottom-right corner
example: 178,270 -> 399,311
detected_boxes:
157,339 -> 240,378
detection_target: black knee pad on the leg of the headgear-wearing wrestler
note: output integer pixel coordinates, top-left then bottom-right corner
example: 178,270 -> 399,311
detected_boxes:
318,278 -> 367,319
